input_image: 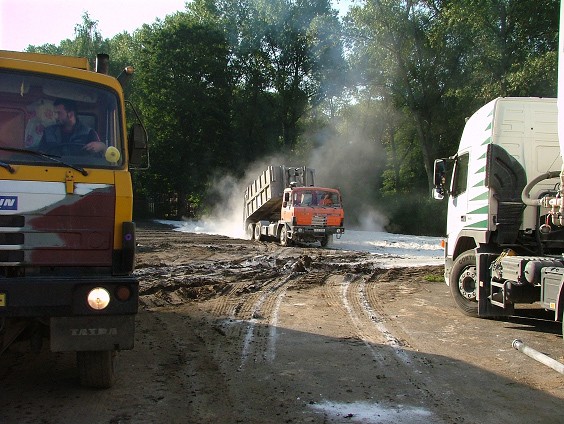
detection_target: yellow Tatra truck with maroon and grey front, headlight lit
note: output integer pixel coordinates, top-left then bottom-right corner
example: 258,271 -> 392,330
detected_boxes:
0,51 -> 147,388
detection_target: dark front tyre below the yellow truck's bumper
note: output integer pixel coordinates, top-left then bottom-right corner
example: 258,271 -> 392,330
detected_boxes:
76,350 -> 116,389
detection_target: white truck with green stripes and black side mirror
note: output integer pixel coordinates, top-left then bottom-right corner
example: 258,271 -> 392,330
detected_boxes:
434,5 -> 564,342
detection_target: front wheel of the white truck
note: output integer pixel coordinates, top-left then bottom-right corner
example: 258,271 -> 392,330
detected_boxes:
449,250 -> 478,317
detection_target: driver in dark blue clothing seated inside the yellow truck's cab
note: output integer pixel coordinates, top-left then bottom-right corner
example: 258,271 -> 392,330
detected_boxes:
39,99 -> 106,153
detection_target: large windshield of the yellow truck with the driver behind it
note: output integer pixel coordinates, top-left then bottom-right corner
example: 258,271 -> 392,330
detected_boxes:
0,71 -> 124,168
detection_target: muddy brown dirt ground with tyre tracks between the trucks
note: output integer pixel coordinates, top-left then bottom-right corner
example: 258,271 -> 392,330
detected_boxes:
0,224 -> 564,424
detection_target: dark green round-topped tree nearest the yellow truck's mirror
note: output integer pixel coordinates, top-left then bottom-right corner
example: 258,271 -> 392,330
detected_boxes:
133,13 -> 231,217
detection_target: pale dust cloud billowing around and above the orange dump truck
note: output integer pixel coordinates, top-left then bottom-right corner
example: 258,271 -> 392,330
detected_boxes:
187,109 -> 388,238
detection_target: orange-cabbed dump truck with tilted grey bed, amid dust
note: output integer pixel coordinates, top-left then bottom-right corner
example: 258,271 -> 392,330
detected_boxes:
244,165 -> 345,247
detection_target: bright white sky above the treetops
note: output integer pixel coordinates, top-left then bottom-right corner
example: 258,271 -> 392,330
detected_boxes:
0,0 -> 354,51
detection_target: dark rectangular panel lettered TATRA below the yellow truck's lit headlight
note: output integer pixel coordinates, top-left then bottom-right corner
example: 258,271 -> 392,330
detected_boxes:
50,315 -> 135,352
